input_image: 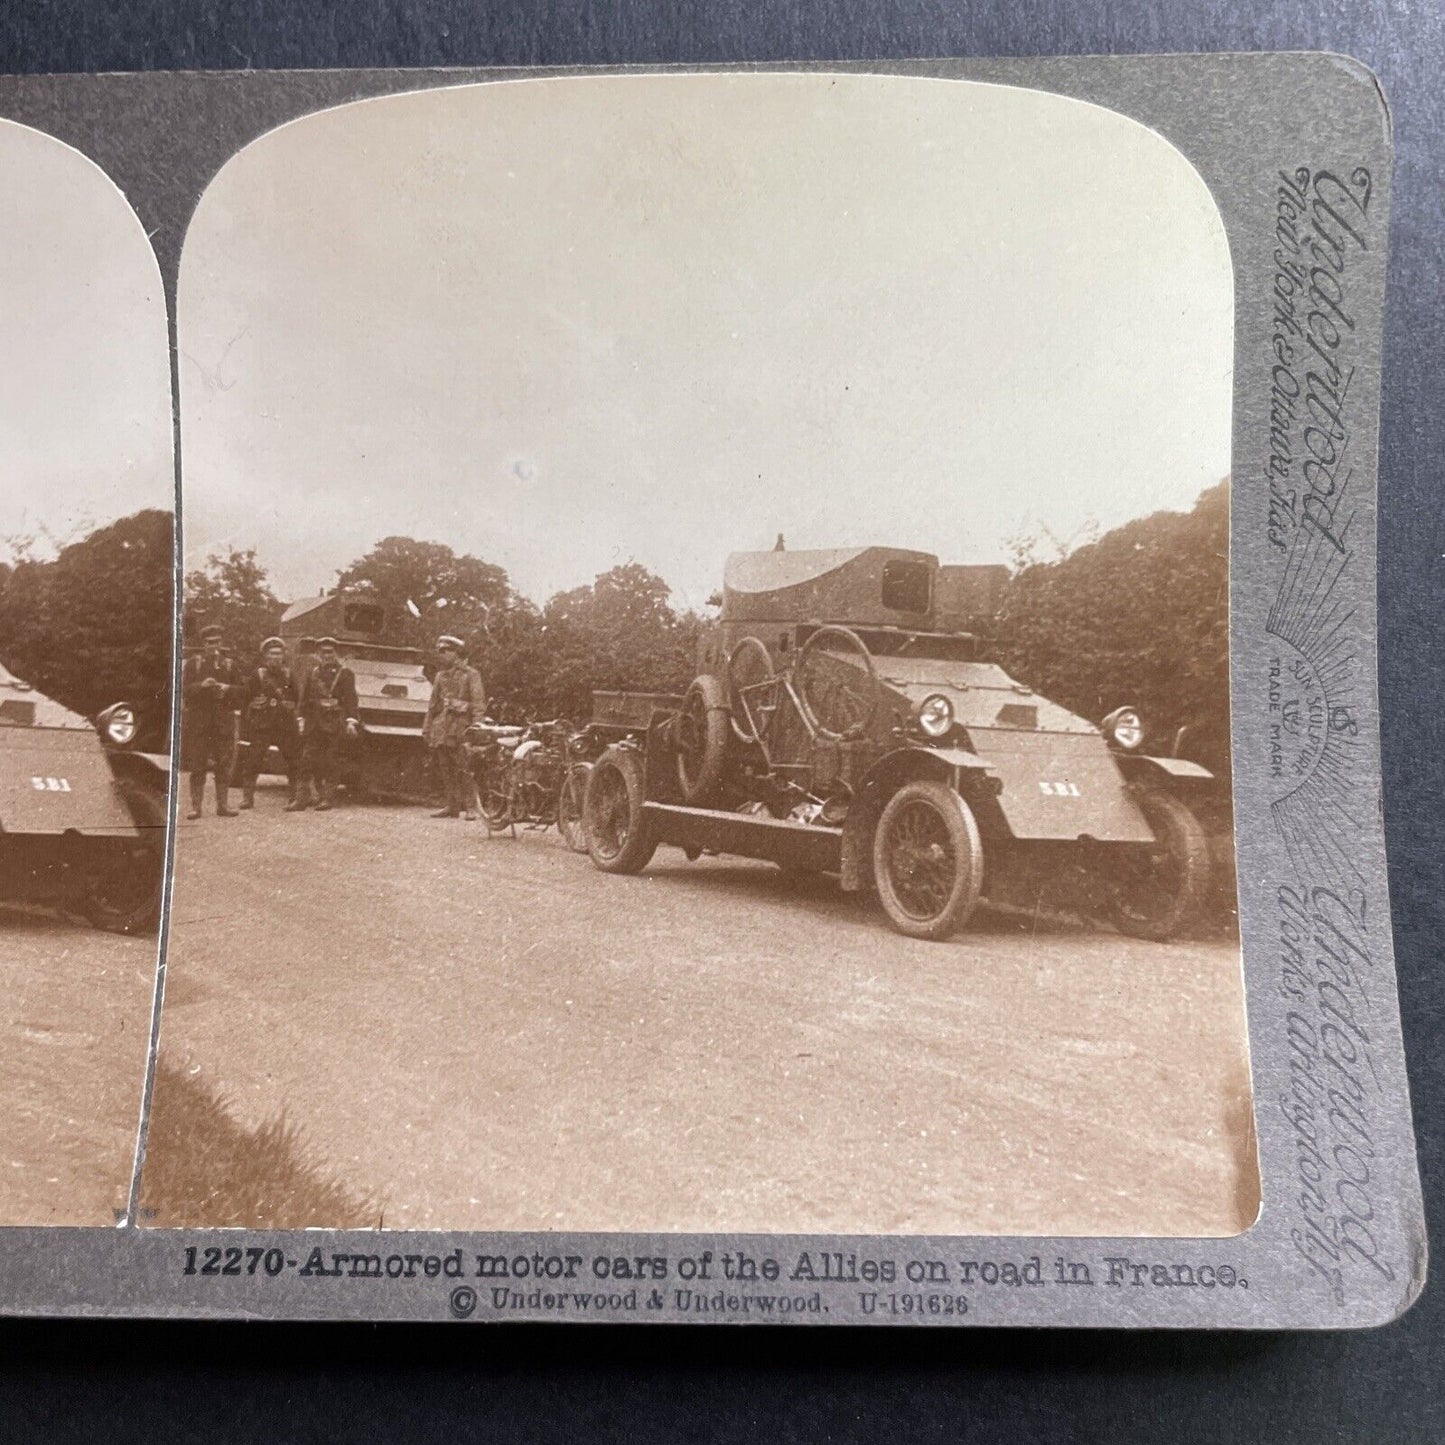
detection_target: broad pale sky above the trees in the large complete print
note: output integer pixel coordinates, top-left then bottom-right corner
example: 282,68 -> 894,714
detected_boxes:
181,75 -> 1233,604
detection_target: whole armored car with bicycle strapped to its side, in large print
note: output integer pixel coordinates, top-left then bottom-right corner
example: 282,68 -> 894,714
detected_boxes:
584,548 -> 1220,939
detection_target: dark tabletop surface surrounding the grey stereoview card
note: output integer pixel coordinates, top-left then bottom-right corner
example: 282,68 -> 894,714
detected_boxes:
0,0 -> 1445,1445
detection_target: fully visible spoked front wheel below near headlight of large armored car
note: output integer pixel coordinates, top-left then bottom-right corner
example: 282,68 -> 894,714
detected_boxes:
873,780 -> 984,938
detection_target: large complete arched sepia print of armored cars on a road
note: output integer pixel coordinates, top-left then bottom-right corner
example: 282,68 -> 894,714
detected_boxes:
140,72 -> 1260,1237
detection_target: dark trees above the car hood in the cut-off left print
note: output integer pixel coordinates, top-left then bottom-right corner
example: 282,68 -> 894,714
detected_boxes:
0,510 -> 175,734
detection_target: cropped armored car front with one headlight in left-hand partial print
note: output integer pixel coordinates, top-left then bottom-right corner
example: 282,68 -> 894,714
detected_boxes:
0,666 -> 169,933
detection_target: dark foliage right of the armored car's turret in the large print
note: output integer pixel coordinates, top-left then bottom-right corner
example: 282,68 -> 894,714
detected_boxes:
997,483 -> 1230,775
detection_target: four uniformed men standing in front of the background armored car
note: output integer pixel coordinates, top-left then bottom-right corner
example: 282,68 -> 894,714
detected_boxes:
181,626 -> 487,819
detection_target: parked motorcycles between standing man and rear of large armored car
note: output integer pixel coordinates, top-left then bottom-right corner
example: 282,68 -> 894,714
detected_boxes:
467,718 -> 594,853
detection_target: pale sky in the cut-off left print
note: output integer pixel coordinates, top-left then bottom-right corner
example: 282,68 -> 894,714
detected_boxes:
0,120 -> 175,559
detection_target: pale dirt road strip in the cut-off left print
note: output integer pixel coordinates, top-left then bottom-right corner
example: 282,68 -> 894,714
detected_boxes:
0,907 -> 156,1225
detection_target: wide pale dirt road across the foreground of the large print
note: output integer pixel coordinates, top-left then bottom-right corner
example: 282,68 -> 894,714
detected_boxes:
152,792 -> 1257,1235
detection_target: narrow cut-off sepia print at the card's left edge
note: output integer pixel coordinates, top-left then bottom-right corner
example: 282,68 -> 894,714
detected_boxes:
0,121 -> 175,1225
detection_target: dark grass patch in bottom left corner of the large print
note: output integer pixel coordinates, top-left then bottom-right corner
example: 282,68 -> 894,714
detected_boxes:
140,1061 -> 381,1230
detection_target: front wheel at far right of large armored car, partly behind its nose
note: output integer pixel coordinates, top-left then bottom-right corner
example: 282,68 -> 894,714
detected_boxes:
1108,792 -> 1209,944
